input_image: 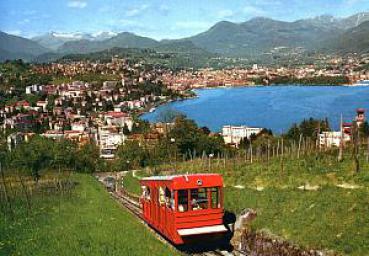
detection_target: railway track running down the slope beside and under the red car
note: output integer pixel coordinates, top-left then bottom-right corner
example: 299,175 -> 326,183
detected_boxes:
110,188 -> 236,256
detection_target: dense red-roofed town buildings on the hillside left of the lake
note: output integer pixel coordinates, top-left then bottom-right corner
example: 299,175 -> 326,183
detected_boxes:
0,59 -> 178,159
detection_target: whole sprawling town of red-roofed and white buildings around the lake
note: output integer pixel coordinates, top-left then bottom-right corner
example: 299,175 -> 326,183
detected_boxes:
0,51 -> 369,159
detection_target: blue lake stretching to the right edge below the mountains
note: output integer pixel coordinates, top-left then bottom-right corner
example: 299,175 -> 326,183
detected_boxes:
142,85 -> 369,133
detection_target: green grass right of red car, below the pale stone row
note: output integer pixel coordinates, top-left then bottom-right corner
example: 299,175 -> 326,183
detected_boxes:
225,187 -> 369,256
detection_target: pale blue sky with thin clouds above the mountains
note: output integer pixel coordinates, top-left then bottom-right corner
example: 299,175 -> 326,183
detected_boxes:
0,0 -> 369,39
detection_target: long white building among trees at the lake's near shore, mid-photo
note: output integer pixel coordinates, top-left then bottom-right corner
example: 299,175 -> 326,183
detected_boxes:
222,125 -> 263,145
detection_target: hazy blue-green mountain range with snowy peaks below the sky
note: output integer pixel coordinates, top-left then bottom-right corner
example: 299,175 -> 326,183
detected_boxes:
0,12 -> 369,60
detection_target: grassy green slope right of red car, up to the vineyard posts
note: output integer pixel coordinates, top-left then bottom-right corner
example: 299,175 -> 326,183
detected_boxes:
128,152 -> 369,256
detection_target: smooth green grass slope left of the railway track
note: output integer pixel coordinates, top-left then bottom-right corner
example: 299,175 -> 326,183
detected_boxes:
0,174 -> 176,256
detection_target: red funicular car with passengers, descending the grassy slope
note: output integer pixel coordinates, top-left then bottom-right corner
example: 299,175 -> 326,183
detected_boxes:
140,174 -> 227,245
